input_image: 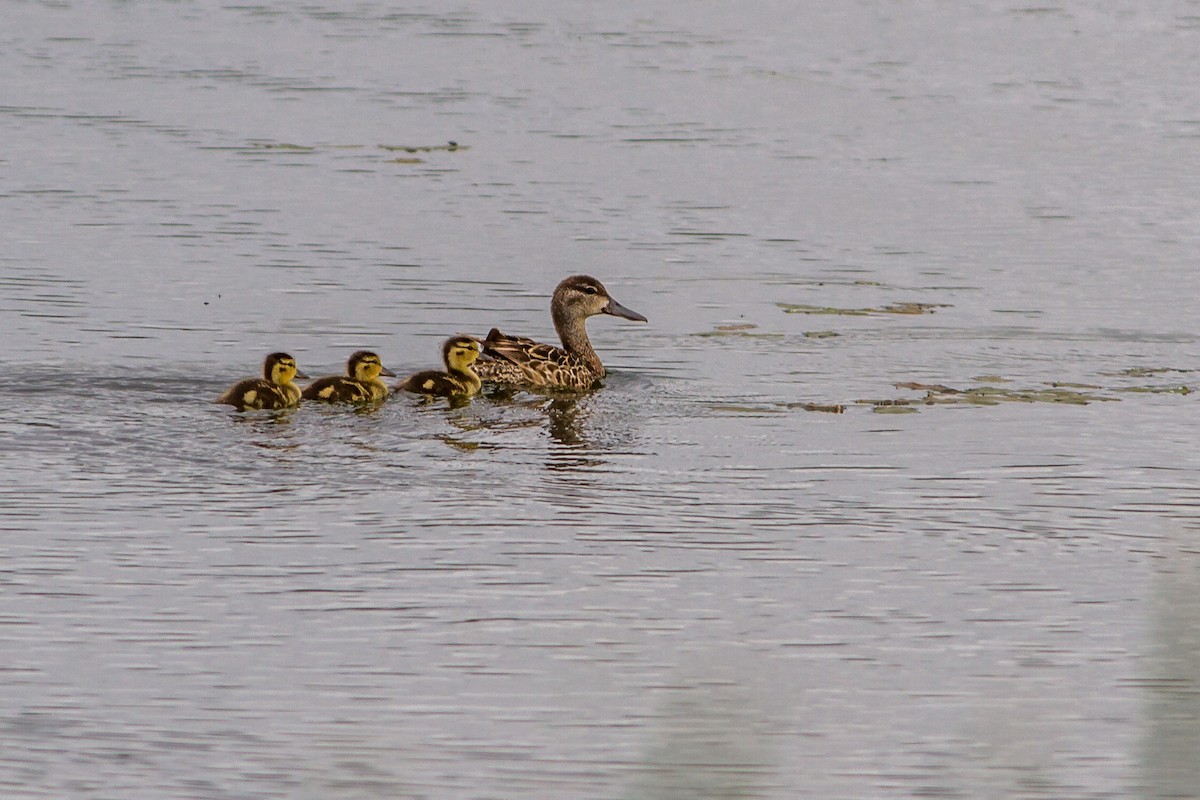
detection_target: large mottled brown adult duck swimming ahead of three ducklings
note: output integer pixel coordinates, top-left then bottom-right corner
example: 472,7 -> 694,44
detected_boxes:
475,275 -> 647,390
